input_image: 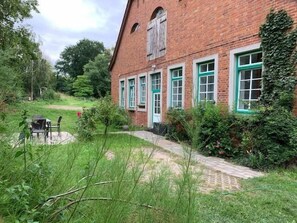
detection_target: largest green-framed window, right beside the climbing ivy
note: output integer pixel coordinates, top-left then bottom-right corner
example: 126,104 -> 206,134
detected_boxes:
235,51 -> 263,113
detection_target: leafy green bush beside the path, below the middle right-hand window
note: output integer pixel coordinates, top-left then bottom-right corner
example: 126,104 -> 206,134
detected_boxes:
167,103 -> 238,157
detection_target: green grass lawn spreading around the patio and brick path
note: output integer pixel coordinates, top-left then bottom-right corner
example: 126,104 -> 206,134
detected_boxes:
0,98 -> 297,223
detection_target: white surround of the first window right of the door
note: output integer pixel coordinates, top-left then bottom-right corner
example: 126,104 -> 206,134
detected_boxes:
167,63 -> 186,109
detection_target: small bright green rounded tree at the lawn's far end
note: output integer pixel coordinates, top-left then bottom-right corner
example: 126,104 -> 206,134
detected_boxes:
73,75 -> 93,97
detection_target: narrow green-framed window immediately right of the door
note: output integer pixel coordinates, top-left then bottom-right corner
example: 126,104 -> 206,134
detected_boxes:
170,67 -> 183,108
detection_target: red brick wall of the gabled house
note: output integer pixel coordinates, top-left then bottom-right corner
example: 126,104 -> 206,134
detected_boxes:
112,0 -> 297,125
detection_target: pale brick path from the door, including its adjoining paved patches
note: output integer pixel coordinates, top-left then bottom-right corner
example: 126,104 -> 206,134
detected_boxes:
126,131 -> 264,193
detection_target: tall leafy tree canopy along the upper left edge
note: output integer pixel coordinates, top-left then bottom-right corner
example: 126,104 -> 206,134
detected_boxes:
0,0 -> 53,103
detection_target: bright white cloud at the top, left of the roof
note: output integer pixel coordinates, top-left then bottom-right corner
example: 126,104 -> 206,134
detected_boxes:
38,0 -> 109,32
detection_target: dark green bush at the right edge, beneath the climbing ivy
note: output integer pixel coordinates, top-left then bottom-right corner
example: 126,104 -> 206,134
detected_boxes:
243,108 -> 297,169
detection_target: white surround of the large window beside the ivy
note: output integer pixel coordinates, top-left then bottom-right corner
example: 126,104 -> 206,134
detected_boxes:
228,43 -> 264,111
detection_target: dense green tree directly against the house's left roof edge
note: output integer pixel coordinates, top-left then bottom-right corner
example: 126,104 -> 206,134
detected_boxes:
84,51 -> 111,98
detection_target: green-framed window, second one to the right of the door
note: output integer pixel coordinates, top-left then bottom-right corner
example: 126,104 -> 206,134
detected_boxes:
197,60 -> 215,102
